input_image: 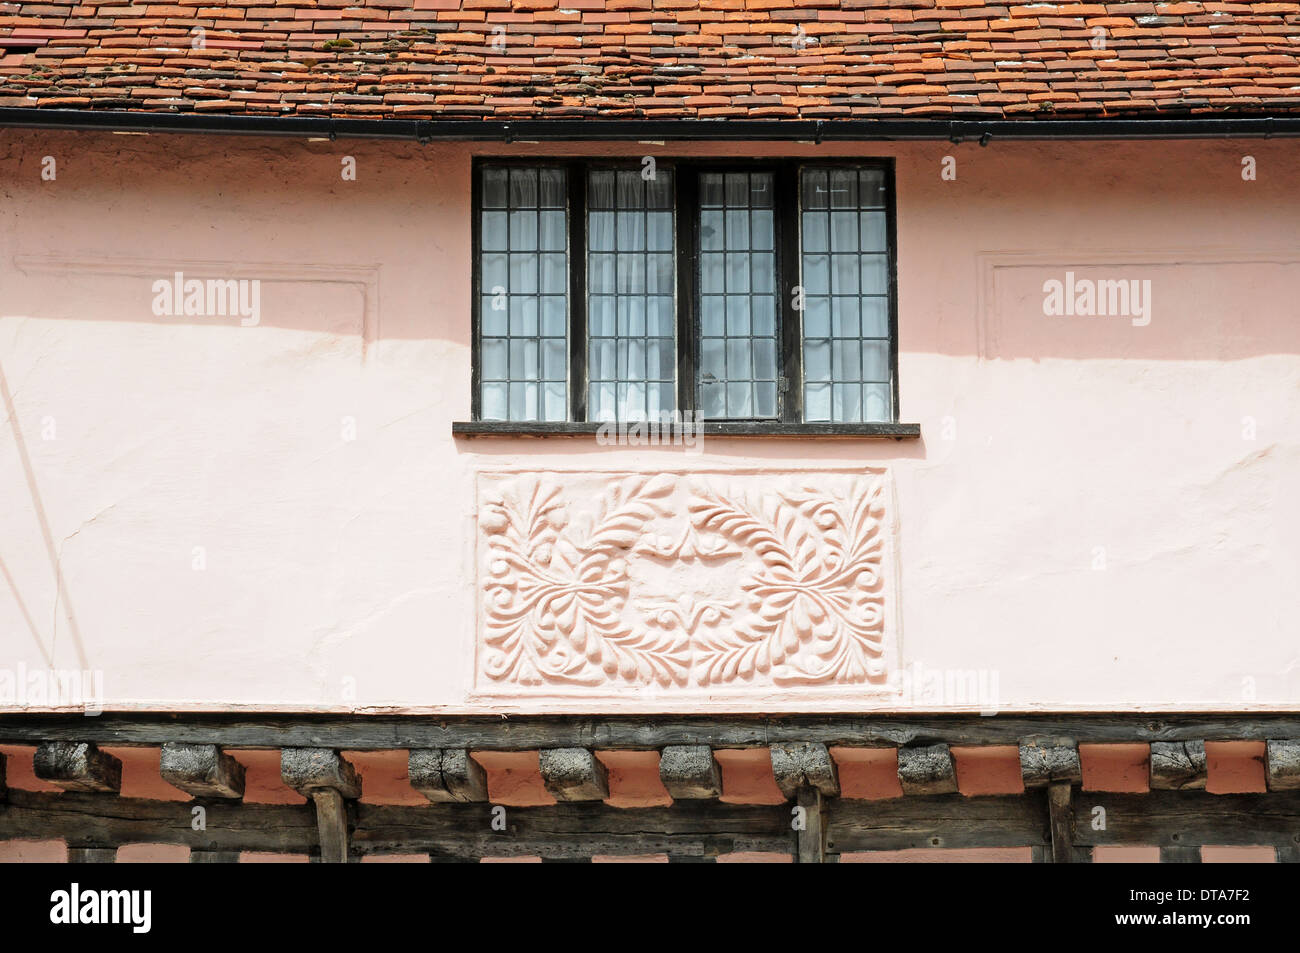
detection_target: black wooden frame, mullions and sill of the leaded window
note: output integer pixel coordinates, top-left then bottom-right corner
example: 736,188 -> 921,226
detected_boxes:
452,155 -> 920,438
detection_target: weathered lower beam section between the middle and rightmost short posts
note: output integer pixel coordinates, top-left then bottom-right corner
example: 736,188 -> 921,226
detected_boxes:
826,794 -> 1050,854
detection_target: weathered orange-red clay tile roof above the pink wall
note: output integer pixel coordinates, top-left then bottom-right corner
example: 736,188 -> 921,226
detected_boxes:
0,0 -> 1300,120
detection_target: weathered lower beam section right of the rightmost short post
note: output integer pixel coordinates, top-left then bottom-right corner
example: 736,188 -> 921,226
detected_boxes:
1074,790 -> 1300,846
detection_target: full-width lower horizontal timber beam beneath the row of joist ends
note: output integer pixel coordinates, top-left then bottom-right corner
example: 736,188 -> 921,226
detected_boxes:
15,789 -> 1300,862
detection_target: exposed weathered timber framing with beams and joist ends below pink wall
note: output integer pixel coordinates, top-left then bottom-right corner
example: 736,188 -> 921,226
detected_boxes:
0,715 -> 1300,863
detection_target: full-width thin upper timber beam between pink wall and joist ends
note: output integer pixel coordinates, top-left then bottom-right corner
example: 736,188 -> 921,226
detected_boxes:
0,712 -> 1300,751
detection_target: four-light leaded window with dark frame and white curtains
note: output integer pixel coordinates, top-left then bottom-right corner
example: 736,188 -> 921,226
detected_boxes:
470,160 -> 914,436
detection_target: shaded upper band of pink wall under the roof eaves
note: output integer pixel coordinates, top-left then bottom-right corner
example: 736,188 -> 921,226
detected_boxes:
0,133 -> 1300,360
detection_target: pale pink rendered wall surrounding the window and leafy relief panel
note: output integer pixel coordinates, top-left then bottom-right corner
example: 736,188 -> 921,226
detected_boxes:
0,131 -> 1300,712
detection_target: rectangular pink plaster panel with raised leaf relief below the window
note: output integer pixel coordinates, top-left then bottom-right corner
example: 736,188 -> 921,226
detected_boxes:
477,471 -> 893,693
